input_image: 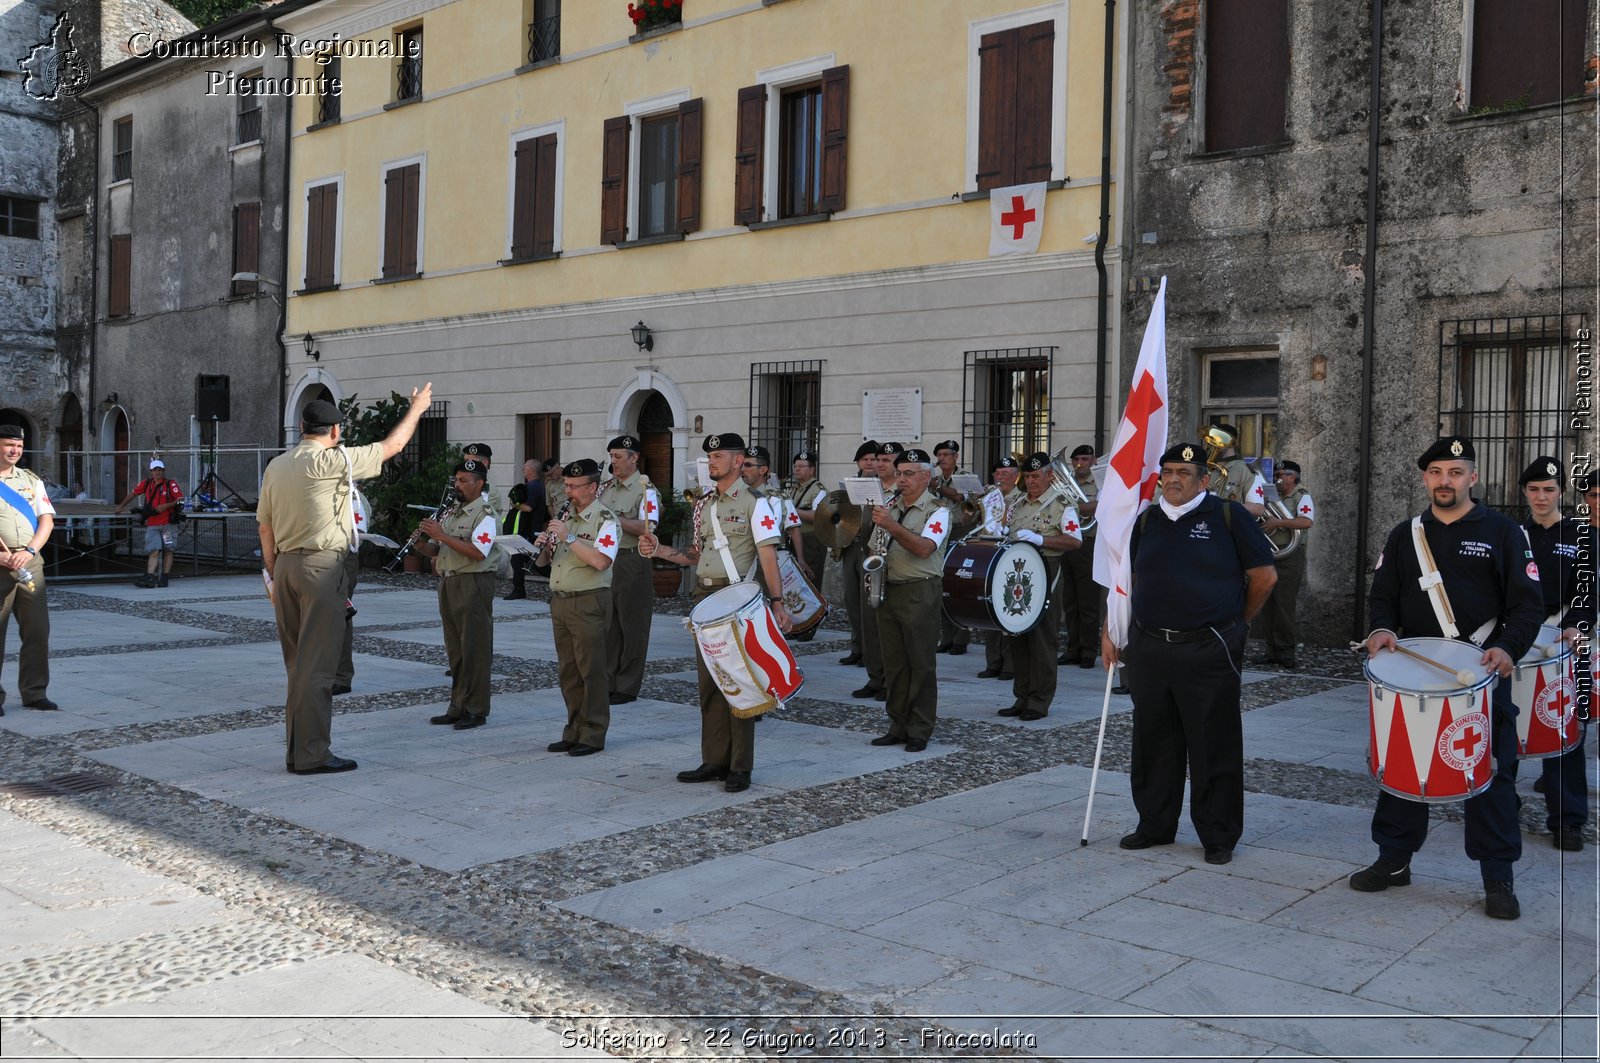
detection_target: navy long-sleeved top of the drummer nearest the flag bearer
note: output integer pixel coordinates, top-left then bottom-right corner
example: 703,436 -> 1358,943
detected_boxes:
1371,503 -> 1544,661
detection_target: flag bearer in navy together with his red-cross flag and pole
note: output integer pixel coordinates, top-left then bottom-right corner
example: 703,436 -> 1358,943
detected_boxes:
1080,279 -> 1277,864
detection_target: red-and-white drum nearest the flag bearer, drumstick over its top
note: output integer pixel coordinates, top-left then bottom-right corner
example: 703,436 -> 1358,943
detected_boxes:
1366,639 -> 1498,804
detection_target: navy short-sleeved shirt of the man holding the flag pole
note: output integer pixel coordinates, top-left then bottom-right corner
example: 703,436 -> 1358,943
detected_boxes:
1128,495 -> 1272,631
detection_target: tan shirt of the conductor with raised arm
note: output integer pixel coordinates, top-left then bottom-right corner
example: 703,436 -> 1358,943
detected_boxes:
256,439 -> 384,552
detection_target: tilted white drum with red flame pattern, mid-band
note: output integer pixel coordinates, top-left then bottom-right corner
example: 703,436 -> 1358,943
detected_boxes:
690,583 -> 805,717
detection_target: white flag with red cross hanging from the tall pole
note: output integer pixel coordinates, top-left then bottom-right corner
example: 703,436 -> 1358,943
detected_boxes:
1094,277 -> 1168,650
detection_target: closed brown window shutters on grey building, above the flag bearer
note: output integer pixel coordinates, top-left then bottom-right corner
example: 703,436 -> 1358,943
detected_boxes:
1205,0 -> 1290,152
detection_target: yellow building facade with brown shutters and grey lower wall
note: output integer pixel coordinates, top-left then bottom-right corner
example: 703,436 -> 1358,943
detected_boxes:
280,0 -> 1122,480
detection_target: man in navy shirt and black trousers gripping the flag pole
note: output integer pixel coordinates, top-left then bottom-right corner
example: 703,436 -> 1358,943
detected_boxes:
1101,443 -> 1278,864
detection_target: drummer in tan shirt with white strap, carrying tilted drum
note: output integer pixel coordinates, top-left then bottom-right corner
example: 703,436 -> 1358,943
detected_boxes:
646,432 -> 790,794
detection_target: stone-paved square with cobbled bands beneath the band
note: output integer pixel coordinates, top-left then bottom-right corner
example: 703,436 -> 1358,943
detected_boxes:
0,575 -> 1600,1060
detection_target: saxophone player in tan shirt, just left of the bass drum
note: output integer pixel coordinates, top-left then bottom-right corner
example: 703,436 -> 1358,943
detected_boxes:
872,450 -> 950,752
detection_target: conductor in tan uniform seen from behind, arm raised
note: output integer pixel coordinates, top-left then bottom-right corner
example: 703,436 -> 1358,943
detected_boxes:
256,383 -> 434,775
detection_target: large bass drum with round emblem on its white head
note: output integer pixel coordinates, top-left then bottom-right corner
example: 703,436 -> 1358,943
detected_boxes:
944,540 -> 1050,636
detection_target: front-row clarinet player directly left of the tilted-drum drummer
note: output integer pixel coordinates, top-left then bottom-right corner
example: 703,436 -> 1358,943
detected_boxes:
539,457 -> 611,757
